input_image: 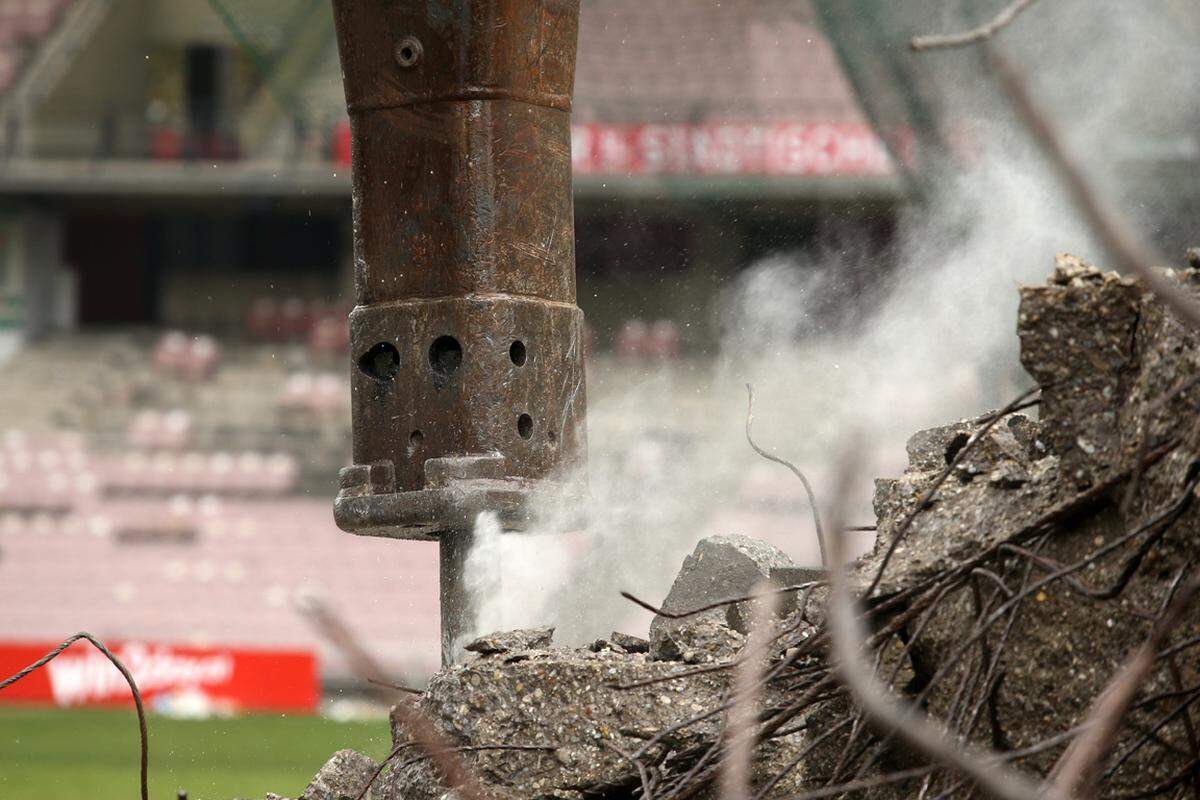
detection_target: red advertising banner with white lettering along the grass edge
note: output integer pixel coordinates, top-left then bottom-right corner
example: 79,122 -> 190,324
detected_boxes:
0,640 -> 319,715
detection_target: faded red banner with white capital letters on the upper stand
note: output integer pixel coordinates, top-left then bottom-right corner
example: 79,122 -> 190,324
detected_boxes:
332,122 -> 893,178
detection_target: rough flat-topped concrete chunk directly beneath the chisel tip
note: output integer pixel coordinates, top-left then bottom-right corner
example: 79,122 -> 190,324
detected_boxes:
377,647 -> 748,800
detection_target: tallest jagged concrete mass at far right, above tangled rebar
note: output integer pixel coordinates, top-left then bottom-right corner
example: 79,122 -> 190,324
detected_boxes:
856,259 -> 1200,796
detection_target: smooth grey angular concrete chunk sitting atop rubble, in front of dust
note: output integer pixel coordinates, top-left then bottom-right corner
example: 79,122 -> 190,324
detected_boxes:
650,536 -> 796,643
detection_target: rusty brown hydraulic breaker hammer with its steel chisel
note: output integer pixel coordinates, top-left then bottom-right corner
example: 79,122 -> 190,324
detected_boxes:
334,0 -> 587,662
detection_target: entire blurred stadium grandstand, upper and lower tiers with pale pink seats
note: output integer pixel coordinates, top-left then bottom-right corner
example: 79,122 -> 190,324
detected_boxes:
0,0 -> 901,700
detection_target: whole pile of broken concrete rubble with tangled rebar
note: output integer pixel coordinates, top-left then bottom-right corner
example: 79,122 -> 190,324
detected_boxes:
288,255 -> 1200,800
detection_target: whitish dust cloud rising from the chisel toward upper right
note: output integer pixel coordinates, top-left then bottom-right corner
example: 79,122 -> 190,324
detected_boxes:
458,0 -> 1200,644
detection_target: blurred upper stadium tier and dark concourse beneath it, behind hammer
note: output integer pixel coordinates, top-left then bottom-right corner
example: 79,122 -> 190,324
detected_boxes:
0,0 -> 896,347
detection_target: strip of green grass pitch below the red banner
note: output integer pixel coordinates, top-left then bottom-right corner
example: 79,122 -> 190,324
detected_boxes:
0,708 -> 389,800
